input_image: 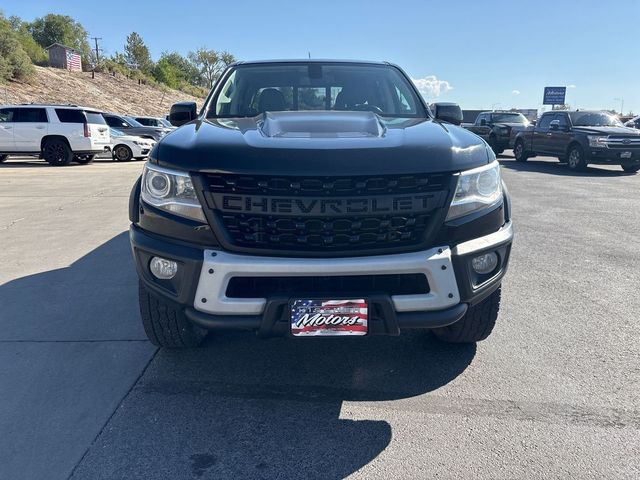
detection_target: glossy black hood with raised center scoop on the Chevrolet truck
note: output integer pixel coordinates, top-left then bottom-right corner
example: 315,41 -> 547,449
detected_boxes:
151,111 -> 493,175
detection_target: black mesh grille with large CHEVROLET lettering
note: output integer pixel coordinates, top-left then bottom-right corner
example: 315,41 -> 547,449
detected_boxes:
201,174 -> 452,256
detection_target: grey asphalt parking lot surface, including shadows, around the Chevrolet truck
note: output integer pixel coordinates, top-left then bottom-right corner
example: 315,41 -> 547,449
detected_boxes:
0,156 -> 640,480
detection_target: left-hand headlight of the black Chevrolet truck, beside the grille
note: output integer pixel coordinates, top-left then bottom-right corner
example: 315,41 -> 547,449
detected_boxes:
141,162 -> 206,222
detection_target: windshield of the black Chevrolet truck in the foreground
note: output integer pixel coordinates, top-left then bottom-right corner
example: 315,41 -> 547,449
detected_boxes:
207,62 -> 426,118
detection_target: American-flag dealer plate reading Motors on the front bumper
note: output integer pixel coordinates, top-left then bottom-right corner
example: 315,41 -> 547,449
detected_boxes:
290,298 -> 369,337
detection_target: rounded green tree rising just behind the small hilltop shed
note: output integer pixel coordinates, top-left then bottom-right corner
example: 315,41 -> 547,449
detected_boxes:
27,13 -> 91,61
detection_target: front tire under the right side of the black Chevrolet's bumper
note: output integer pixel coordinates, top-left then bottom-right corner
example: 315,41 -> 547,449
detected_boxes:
433,287 -> 502,343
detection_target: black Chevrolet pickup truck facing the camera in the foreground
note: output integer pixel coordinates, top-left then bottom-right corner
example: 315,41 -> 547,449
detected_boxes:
129,60 -> 513,347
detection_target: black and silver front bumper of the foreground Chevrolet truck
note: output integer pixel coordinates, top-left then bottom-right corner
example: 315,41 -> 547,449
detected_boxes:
130,222 -> 513,336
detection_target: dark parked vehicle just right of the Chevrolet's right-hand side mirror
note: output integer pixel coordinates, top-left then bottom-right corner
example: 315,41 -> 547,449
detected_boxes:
462,111 -> 530,155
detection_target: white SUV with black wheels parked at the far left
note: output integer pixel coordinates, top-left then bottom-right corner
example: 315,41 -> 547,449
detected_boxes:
0,104 -> 111,166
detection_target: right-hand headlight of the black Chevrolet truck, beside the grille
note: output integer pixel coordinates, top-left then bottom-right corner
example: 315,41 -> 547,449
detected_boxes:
447,161 -> 502,220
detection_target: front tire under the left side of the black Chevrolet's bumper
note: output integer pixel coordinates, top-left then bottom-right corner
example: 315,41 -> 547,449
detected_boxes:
138,282 -> 207,348
